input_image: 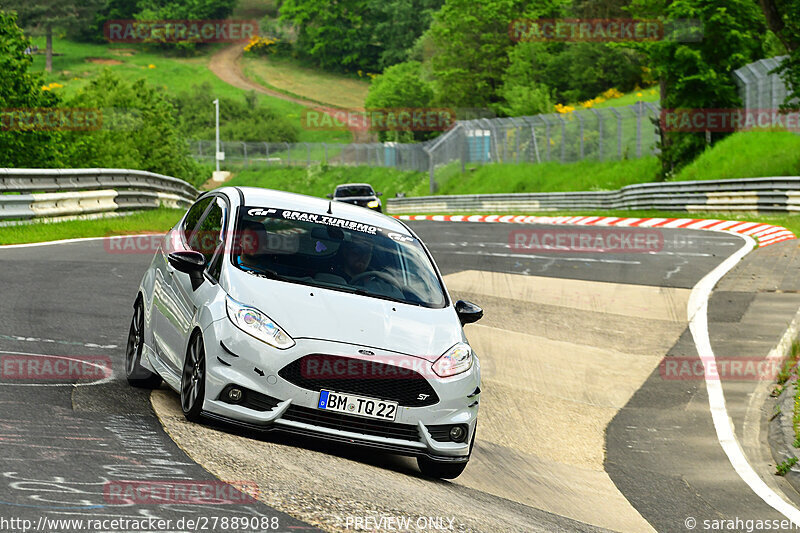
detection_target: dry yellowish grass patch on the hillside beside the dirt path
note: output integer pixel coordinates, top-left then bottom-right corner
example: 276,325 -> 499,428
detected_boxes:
242,55 -> 369,109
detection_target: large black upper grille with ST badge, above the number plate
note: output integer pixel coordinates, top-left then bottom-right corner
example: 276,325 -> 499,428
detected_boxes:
278,354 -> 439,407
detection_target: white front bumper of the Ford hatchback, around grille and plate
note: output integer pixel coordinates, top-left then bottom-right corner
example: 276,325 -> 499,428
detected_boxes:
203,318 -> 480,462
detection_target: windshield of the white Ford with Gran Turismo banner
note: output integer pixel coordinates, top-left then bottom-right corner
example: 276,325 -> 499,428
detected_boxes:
231,207 -> 446,308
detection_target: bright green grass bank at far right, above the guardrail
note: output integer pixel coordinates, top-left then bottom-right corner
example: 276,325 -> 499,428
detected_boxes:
674,131 -> 800,181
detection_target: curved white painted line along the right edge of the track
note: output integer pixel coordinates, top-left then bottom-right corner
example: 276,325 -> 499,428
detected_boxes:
687,236 -> 800,526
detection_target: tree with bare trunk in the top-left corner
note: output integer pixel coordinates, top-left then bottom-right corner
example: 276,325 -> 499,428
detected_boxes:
0,0 -> 102,72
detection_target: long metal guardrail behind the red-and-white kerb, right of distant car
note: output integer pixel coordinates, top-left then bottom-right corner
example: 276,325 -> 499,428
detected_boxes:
386,177 -> 800,214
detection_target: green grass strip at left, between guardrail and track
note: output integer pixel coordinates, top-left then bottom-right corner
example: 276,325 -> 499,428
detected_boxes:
0,208 -> 186,244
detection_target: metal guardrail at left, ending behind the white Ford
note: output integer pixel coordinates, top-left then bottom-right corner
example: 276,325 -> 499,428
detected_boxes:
0,168 -> 198,220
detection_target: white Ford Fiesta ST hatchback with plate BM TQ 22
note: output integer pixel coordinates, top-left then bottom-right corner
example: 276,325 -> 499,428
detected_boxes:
126,187 -> 483,478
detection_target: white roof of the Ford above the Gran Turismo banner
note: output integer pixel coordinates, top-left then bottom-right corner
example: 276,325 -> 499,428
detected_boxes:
215,187 -> 411,235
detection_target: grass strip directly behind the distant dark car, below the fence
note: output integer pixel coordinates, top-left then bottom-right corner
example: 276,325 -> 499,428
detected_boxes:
225,165 -> 428,201
